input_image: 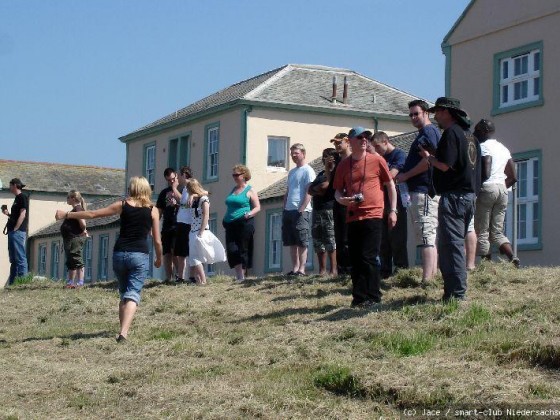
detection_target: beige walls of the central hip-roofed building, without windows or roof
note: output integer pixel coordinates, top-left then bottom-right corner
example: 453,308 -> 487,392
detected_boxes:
127,107 -> 413,275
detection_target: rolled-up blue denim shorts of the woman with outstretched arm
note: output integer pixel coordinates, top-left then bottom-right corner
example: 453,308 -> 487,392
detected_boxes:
113,251 -> 150,304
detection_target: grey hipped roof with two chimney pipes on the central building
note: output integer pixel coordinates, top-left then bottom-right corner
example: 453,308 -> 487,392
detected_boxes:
120,64 -> 419,142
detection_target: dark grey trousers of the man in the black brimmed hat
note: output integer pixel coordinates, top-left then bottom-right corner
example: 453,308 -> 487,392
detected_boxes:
437,192 -> 476,299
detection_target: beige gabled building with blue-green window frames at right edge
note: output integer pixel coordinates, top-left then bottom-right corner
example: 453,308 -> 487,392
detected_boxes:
442,0 -> 560,265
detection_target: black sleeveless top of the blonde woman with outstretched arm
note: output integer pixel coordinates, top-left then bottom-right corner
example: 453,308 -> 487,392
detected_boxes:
113,201 -> 152,254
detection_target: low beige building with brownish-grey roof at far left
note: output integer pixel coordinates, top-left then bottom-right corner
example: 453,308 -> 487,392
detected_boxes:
0,160 -> 125,287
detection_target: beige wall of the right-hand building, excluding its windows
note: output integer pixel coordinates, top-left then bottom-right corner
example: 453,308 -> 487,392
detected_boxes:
448,0 -> 560,265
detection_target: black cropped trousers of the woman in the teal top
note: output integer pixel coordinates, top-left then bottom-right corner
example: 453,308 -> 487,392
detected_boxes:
222,217 -> 255,268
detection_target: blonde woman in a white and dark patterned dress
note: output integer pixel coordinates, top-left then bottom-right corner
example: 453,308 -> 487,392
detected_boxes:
187,178 -> 226,285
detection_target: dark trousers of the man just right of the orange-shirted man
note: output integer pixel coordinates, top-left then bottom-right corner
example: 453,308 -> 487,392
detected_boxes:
379,207 -> 408,278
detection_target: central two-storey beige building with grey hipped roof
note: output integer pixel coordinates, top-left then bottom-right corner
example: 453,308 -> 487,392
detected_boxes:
120,65 -> 424,275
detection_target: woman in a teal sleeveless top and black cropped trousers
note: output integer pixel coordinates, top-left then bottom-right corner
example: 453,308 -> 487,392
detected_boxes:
222,165 -> 261,282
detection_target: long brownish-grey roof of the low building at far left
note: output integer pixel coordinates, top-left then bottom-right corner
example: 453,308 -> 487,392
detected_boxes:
0,160 -> 125,196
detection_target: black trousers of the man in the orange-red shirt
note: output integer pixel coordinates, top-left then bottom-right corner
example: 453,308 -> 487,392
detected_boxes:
348,219 -> 383,304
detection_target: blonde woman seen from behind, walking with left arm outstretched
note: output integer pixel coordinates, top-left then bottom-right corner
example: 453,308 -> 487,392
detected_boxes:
55,177 -> 162,342
